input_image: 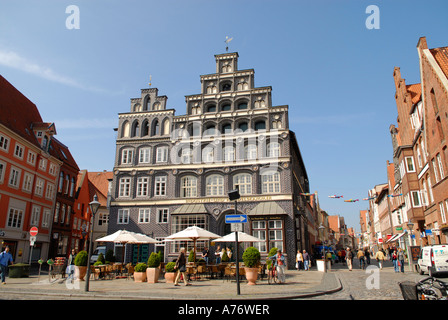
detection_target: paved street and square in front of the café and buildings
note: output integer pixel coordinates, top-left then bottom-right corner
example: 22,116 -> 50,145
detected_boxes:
0,260 -> 440,300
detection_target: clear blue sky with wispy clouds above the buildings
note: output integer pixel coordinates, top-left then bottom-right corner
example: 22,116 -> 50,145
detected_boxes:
0,0 -> 448,231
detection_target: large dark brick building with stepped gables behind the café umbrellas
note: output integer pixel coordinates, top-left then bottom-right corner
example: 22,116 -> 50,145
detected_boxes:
108,53 -> 310,267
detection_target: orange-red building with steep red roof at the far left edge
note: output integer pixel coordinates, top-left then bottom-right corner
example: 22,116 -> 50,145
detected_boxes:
0,76 -> 62,263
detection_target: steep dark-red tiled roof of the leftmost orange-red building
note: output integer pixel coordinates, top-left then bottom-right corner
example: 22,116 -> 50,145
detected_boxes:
0,75 -> 43,148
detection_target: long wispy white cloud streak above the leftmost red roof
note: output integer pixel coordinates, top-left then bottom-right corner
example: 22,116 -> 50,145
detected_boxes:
0,50 -> 106,92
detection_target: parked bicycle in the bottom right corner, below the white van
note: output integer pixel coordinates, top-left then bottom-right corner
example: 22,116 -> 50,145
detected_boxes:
399,277 -> 448,300
